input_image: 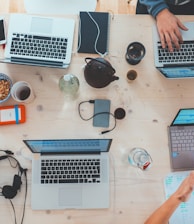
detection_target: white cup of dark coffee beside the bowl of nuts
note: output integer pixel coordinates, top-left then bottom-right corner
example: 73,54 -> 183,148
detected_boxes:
11,81 -> 35,103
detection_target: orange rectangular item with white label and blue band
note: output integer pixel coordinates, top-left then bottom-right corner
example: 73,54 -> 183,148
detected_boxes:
0,105 -> 26,125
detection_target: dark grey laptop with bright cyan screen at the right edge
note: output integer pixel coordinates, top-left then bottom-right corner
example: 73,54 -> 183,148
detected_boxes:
168,108 -> 194,170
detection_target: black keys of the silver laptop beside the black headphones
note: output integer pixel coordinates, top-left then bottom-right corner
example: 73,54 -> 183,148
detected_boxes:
41,159 -> 100,184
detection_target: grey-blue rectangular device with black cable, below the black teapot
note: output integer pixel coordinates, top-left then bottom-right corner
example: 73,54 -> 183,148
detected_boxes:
93,99 -> 110,127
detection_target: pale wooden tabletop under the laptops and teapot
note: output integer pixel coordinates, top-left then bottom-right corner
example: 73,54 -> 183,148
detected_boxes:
0,15 -> 194,224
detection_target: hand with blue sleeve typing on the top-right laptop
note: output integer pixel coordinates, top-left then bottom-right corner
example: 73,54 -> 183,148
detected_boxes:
156,9 -> 188,52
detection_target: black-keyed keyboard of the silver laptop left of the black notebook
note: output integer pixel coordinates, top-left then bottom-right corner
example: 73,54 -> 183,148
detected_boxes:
10,33 -> 68,60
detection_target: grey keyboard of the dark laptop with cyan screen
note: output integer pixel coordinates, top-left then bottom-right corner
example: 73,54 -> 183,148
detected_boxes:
171,127 -> 194,151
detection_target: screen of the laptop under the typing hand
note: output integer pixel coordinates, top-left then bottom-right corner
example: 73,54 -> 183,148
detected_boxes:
158,66 -> 194,78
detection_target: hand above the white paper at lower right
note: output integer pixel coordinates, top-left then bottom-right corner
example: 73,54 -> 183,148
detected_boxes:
174,171 -> 194,202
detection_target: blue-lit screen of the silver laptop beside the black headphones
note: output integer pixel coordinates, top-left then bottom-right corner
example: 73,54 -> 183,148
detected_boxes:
23,139 -> 112,153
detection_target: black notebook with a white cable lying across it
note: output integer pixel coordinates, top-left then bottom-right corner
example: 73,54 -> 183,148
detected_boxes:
78,12 -> 109,54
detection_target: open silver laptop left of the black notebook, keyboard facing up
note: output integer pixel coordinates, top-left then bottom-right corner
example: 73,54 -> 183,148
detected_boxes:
5,14 -> 75,68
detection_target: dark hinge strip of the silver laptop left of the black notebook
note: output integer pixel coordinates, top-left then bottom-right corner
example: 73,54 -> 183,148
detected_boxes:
11,57 -> 63,67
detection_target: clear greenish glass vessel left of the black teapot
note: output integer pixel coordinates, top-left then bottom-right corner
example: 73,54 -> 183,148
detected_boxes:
59,74 -> 79,99
